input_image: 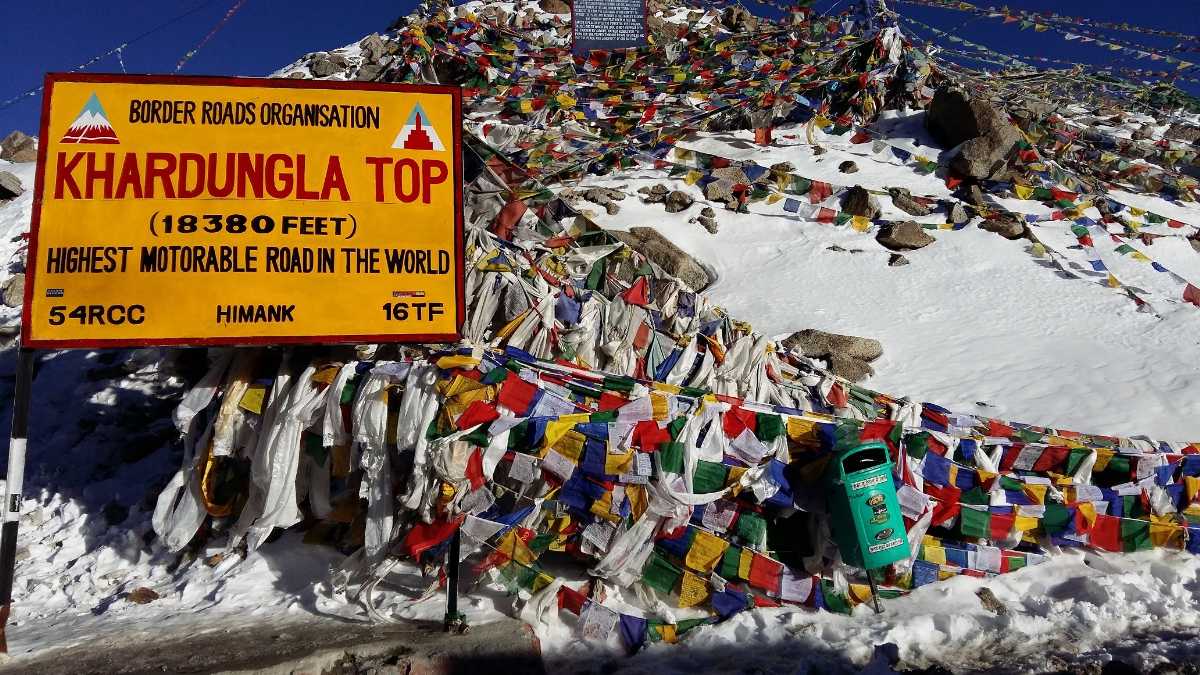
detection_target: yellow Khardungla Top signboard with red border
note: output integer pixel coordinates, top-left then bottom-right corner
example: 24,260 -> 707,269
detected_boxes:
22,74 -> 463,347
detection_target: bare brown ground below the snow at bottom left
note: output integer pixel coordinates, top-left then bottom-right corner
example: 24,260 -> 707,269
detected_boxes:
0,619 -> 544,675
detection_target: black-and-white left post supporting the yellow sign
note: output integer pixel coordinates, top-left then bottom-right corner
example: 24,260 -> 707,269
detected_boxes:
0,347 -> 34,653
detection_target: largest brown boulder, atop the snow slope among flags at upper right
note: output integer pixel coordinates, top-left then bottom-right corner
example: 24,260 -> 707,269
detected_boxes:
925,86 -> 1021,179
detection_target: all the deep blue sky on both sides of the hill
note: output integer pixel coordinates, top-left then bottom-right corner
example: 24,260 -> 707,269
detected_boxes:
0,0 -> 1200,135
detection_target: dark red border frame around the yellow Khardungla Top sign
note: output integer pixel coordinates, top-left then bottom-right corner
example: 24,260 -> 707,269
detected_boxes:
20,72 -> 467,350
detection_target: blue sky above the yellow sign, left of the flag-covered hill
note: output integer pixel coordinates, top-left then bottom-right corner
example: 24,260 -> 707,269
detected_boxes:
0,0 -> 403,136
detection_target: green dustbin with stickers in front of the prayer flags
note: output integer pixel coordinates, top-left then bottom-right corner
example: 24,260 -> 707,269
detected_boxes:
826,441 -> 908,571
